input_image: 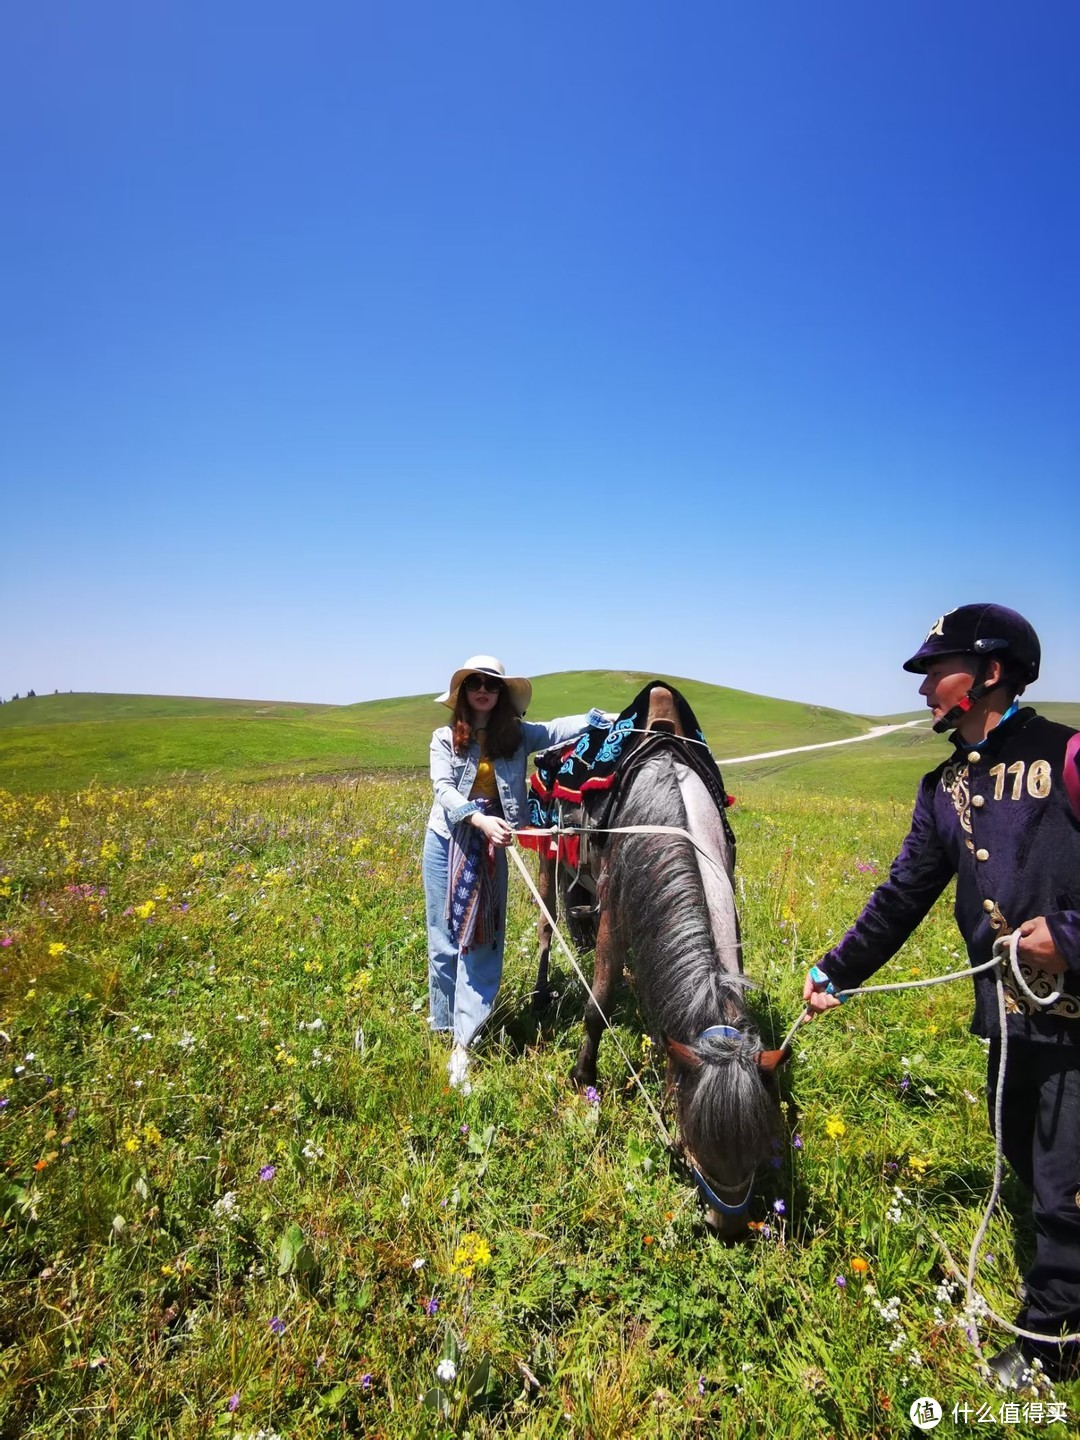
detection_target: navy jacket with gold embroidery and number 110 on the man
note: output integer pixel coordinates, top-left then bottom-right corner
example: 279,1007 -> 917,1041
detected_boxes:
821,708 -> 1080,1045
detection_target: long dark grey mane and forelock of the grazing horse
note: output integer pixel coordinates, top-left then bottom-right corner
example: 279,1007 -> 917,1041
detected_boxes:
606,744 -> 775,1179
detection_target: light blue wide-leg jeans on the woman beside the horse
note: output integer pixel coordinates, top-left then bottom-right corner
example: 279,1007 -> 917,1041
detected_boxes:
423,829 -> 507,1045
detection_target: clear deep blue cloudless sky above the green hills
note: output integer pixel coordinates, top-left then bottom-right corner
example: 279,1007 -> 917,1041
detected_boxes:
0,0 -> 1080,713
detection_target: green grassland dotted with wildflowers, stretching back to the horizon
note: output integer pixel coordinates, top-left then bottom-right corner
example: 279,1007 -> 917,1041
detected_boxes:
0,672 -> 1080,1440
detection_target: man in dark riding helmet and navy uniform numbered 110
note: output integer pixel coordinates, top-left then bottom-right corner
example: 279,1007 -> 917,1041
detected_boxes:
804,605 -> 1080,1385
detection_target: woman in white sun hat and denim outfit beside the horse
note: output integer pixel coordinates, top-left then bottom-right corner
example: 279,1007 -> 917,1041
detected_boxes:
423,655 -> 605,1094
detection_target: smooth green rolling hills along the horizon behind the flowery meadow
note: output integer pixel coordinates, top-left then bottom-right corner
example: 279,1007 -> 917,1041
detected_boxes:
0,671 -> 1080,796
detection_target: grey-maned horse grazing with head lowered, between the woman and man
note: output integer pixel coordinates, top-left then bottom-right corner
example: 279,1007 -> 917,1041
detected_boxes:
534,683 -> 783,1238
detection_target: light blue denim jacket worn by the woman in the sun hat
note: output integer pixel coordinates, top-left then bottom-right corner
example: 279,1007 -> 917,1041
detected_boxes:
428,710 -> 606,840
